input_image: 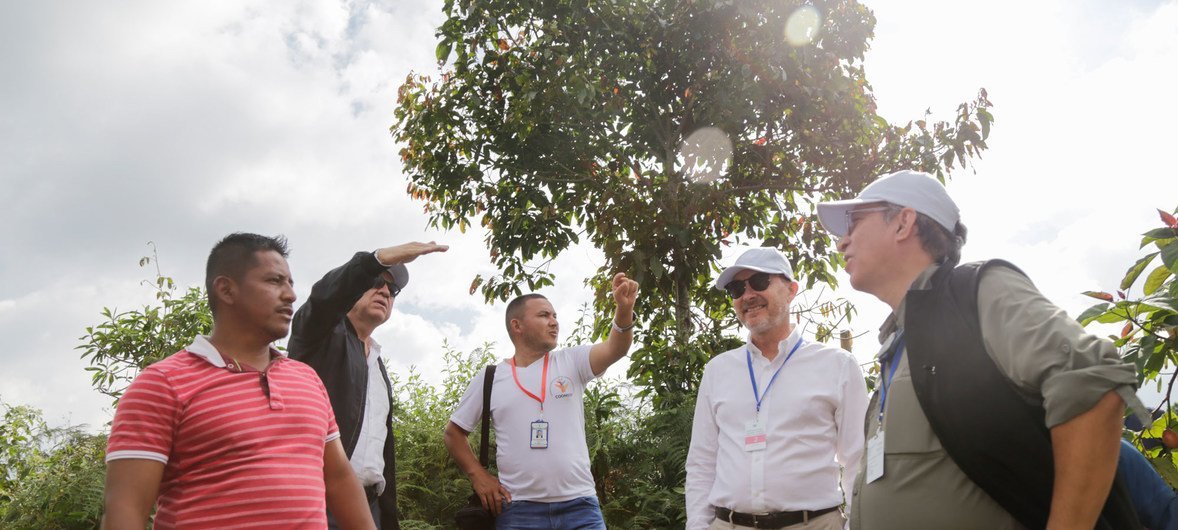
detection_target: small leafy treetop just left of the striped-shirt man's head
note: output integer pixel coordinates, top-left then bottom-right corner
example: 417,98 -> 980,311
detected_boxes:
77,245 -> 213,403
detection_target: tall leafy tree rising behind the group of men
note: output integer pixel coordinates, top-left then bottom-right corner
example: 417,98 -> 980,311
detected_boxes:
392,0 -> 992,398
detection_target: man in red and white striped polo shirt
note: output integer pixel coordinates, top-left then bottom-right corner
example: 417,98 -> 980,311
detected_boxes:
102,233 -> 375,530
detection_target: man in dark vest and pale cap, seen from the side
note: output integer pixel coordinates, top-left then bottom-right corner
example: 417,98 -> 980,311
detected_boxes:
818,171 -> 1141,530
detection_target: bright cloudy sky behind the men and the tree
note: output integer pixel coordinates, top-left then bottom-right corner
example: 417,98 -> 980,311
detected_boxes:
0,0 -> 1178,429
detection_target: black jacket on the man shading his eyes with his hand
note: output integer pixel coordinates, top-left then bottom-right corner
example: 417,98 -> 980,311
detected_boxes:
287,252 -> 401,530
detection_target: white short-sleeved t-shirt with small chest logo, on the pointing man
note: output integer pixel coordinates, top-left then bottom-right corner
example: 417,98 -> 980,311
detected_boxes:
450,345 -> 597,503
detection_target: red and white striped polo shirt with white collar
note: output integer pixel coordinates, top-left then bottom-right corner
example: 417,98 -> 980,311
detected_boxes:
106,337 -> 339,529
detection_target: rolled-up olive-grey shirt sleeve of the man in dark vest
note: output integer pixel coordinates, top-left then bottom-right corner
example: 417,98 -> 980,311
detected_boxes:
978,266 -> 1143,429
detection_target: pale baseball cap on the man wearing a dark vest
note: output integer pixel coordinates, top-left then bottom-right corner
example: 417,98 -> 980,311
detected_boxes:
818,170 -> 961,238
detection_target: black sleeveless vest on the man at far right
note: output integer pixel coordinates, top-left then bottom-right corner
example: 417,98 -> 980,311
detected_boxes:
904,259 -> 1141,530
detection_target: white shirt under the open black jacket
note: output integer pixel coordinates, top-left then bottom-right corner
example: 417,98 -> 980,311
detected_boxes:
351,337 -> 389,493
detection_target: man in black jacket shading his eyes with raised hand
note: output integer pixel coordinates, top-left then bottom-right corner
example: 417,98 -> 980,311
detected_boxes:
289,241 -> 449,530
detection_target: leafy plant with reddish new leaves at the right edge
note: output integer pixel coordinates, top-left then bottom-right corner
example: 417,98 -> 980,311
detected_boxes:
1077,210 -> 1178,486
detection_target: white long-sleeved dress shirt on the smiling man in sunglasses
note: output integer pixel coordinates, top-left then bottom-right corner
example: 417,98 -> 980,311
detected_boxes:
687,327 -> 867,530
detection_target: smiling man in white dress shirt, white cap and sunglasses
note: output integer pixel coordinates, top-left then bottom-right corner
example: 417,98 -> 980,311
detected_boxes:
687,247 -> 867,530
